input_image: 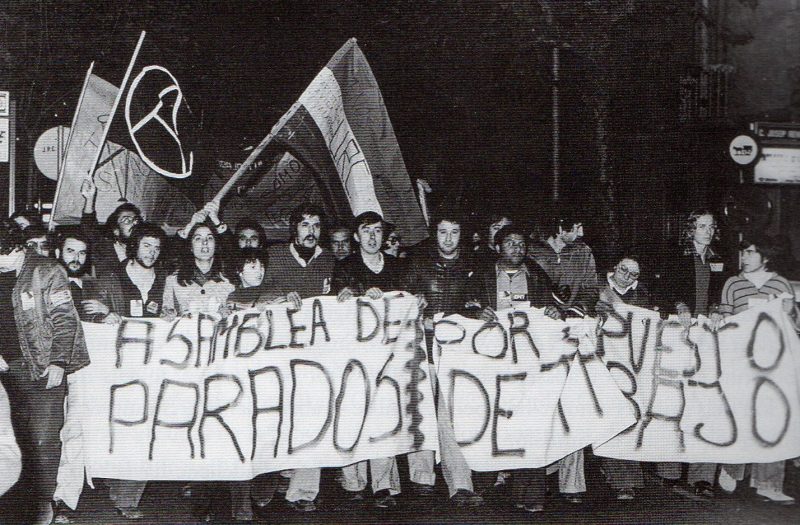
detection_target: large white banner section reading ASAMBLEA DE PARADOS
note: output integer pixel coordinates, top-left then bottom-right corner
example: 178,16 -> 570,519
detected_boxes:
70,295 -> 438,480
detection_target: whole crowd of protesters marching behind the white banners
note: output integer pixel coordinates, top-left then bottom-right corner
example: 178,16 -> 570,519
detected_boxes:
0,175 -> 797,523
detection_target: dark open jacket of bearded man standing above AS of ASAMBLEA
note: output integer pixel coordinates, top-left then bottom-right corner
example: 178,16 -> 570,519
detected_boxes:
100,261 -> 167,317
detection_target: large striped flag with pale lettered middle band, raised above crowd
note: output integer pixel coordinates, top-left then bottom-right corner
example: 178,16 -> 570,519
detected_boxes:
272,38 -> 428,245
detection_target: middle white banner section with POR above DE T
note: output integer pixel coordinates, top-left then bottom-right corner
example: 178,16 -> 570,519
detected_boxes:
433,308 -> 635,471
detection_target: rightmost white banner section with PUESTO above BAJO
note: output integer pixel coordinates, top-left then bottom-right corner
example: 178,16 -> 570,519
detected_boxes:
595,301 -> 800,463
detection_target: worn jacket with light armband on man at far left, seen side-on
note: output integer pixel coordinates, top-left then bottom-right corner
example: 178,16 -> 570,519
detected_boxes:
12,252 -> 89,380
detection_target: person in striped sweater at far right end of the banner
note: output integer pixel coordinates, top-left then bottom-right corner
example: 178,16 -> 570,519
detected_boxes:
719,237 -> 797,505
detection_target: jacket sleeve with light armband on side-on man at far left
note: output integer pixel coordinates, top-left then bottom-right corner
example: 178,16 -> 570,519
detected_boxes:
42,266 -> 80,368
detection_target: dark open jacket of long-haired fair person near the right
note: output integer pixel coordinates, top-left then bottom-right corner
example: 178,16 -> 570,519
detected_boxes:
661,248 -> 732,316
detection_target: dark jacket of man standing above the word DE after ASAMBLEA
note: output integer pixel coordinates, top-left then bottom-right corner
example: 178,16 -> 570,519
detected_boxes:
332,250 -> 405,295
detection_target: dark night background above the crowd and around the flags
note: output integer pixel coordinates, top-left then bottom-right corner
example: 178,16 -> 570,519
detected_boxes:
0,0 -> 800,270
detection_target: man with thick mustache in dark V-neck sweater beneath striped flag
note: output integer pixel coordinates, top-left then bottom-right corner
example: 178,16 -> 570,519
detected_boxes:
260,204 -> 334,513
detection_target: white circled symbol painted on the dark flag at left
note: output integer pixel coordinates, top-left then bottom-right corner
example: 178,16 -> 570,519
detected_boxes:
125,66 -> 194,179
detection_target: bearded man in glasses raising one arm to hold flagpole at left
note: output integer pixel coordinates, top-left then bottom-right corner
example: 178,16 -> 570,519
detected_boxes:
81,178 -> 142,276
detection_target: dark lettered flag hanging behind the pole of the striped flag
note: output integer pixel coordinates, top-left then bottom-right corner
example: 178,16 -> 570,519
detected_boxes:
211,152 -> 332,242
